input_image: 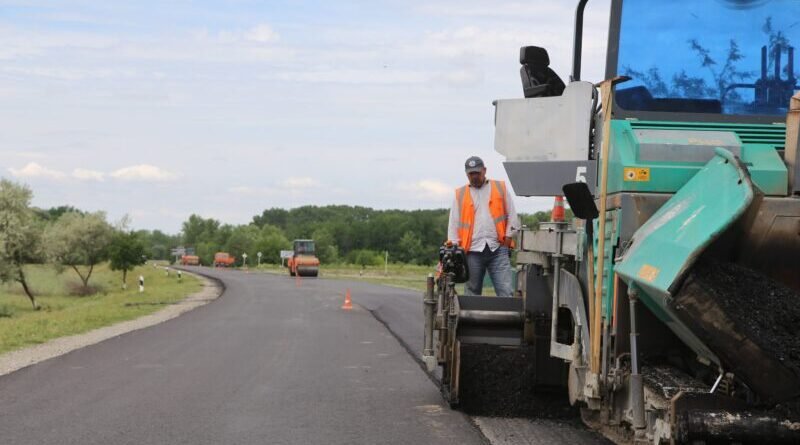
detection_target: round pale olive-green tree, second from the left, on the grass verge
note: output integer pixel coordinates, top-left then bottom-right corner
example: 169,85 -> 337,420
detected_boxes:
45,212 -> 114,288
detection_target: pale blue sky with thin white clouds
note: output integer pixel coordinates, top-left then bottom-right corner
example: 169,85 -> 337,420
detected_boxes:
0,0 -> 608,232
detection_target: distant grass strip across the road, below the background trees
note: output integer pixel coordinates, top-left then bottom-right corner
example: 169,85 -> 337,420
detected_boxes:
252,264 -> 495,295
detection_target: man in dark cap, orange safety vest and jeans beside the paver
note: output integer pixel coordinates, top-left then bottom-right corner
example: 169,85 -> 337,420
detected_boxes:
447,156 -> 520,297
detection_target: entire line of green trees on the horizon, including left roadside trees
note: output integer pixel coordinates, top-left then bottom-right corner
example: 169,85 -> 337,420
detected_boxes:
0,175 -> 571,307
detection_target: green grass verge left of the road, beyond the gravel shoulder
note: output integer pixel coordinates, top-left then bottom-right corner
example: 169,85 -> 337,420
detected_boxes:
0,264 -> 202,353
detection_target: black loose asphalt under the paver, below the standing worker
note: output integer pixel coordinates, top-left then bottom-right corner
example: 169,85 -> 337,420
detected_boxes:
459,345 -> 580,420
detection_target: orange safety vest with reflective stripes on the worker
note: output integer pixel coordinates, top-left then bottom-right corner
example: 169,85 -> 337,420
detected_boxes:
456,180 -> 513,252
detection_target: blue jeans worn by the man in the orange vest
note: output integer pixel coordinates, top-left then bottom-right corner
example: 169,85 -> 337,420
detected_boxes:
465,246 -> 514,297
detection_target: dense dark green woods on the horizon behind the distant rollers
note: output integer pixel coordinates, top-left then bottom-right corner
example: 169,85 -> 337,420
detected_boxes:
181,205 -> 571,266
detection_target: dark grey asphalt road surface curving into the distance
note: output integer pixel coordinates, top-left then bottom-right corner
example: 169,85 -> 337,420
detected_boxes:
0,269 -> 599,445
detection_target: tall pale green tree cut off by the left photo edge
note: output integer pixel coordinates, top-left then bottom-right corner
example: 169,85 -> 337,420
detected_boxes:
0,179 -> 41,309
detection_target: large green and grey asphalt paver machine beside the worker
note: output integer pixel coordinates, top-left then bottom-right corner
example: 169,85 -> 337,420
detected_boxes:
431,0 -> 800,444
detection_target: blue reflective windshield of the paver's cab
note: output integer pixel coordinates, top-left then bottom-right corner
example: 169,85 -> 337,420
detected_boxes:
616,0 -> 800,115
